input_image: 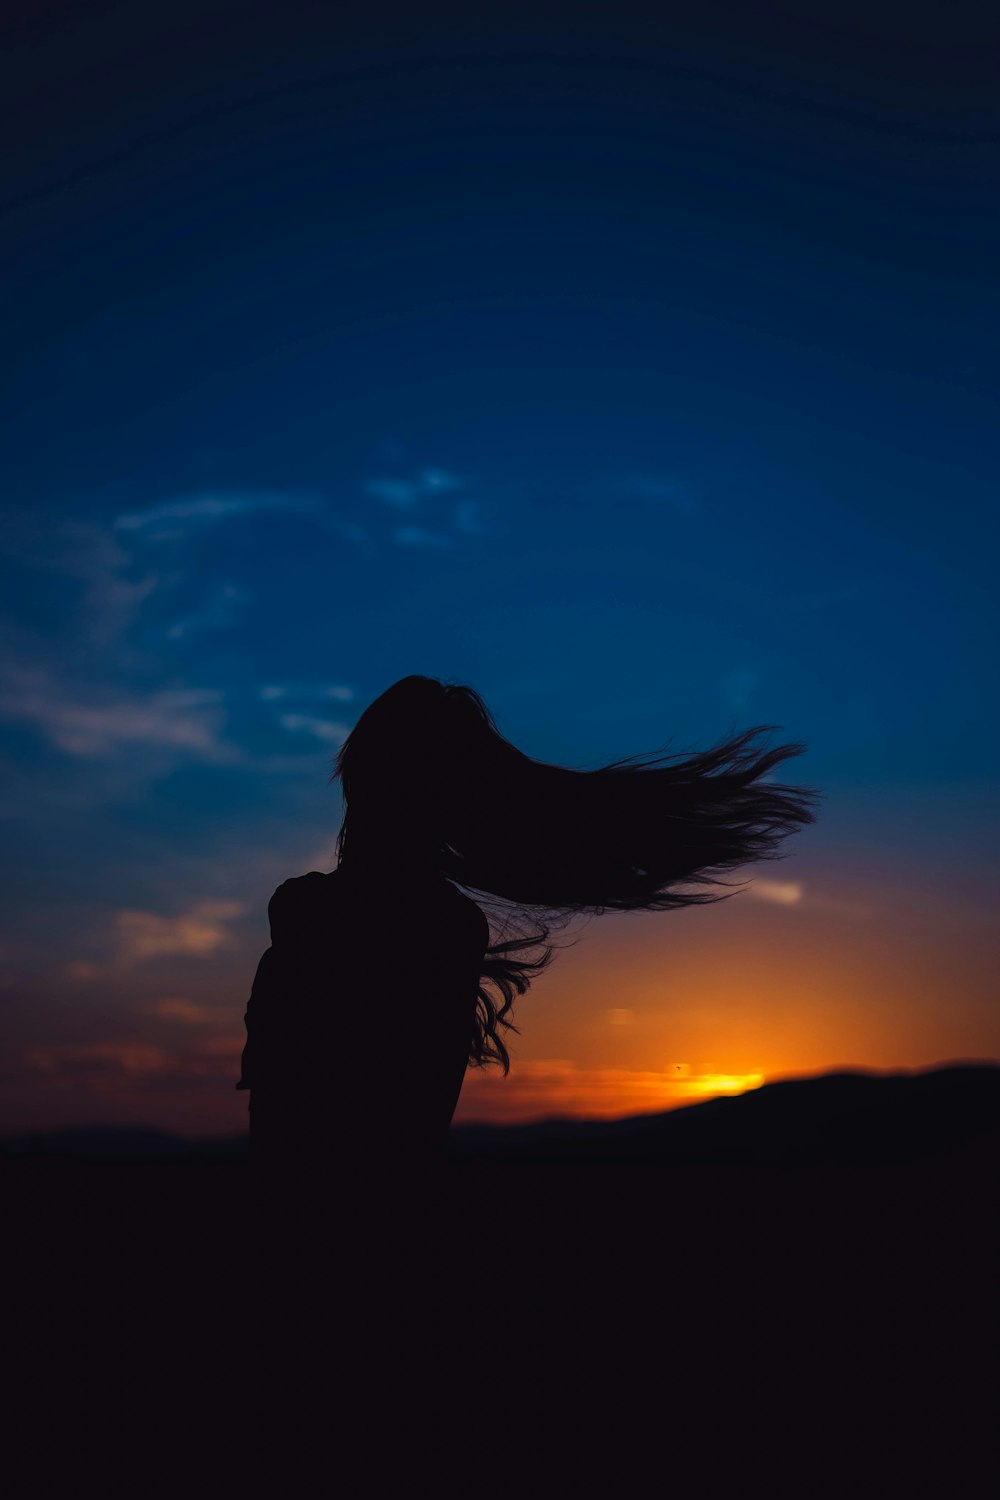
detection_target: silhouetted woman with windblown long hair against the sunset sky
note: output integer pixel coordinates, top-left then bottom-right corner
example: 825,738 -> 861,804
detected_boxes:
237,677 -> 819,1179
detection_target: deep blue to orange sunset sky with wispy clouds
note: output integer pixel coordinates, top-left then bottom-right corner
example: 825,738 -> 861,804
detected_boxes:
0,0 -> 1000,1134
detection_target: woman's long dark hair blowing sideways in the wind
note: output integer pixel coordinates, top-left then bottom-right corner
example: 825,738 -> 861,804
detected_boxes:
330,675 -> 822,1073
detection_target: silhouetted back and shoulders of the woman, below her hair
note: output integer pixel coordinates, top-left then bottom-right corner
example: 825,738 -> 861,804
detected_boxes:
241,867 -> 489,1173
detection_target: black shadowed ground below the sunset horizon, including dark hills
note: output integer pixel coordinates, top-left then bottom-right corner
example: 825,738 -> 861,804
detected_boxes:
3,1067 -> 1000,1476
